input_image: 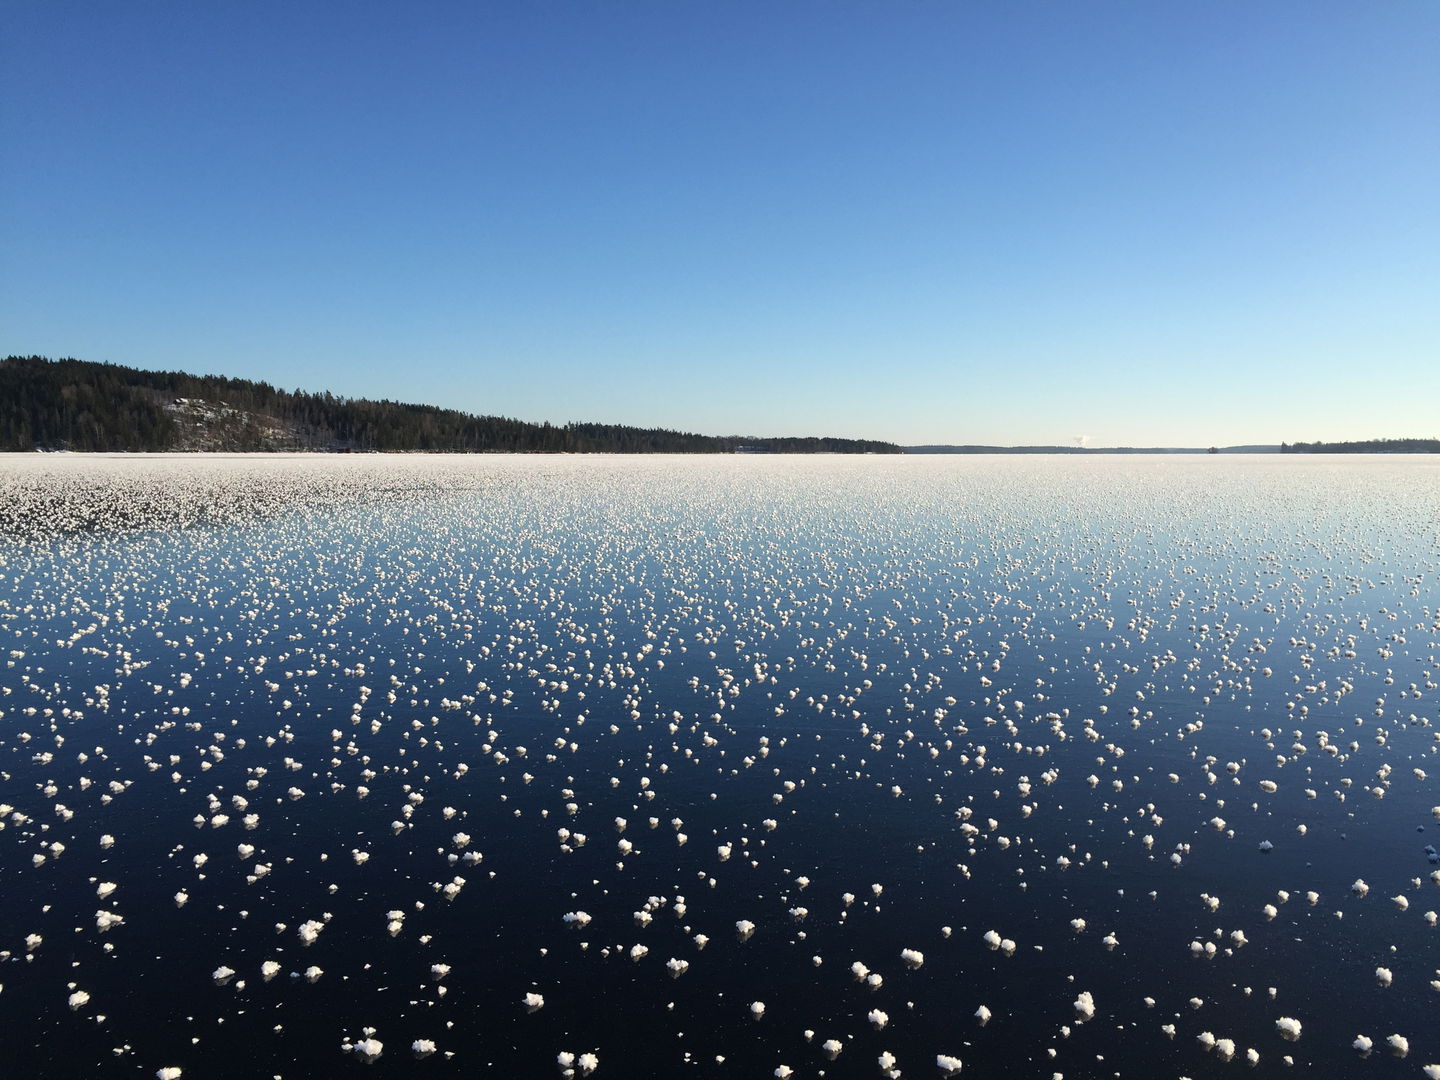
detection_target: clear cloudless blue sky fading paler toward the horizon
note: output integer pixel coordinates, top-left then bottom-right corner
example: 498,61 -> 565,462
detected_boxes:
0,0 -> 1440,445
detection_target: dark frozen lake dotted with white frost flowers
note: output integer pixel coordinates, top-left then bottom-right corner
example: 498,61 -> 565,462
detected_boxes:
0,455 -> 1440,1080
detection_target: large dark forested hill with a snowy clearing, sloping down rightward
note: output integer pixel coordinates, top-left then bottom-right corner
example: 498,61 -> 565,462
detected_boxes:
0,356 -> 900,454
